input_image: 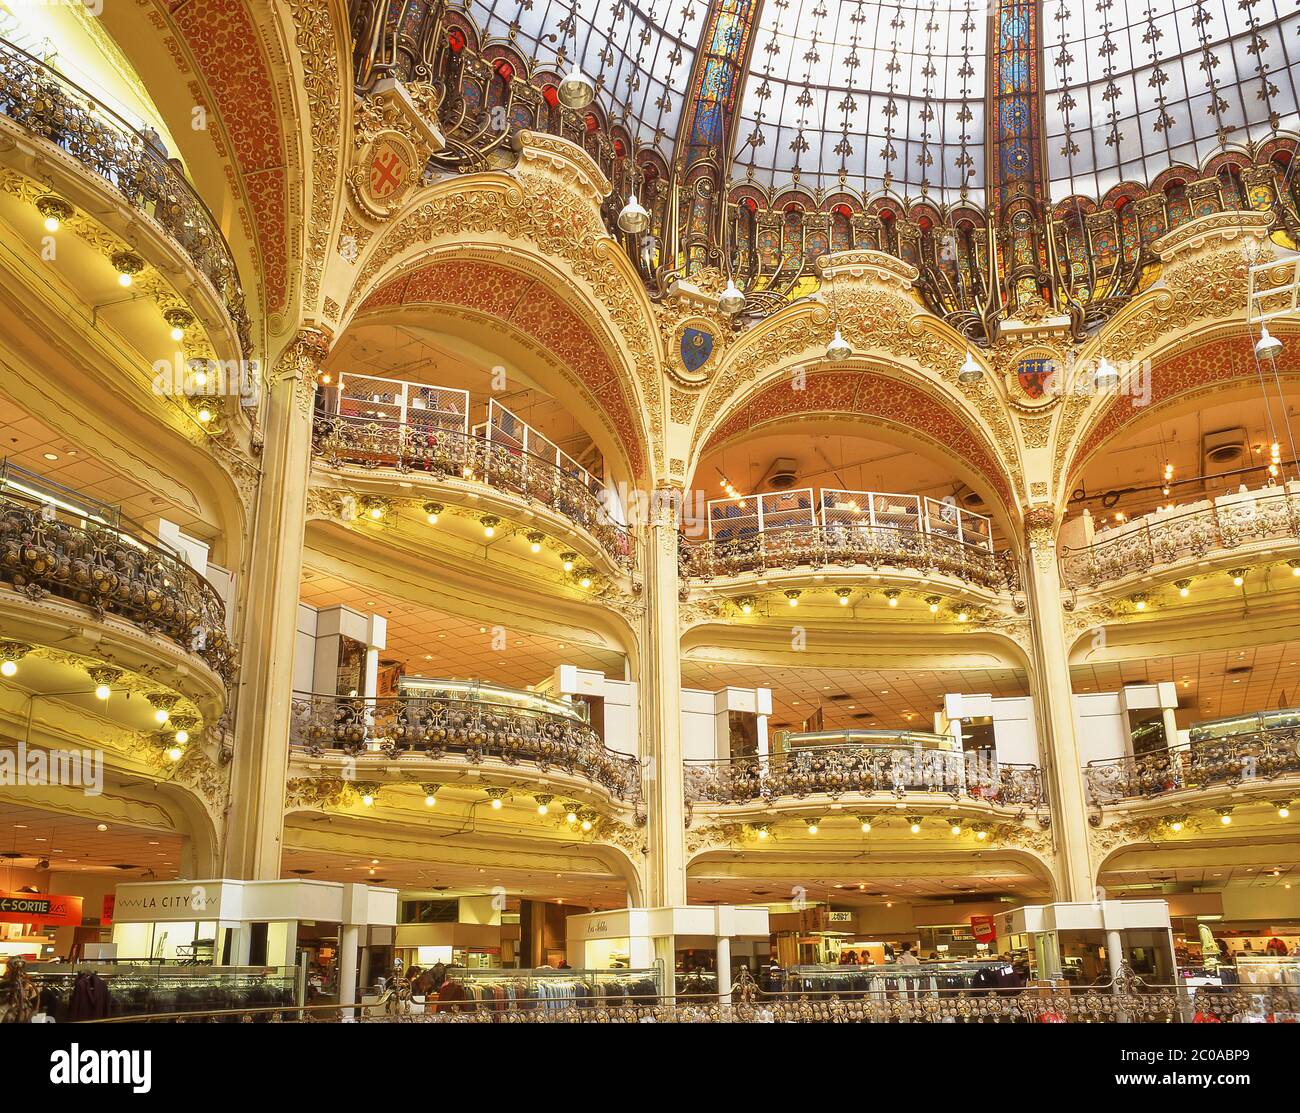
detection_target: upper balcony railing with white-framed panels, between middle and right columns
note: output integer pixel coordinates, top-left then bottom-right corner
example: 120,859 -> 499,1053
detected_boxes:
680,489 -> 1018,592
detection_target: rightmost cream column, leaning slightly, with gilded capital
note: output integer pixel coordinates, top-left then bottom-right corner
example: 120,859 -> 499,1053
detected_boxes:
1024,507 -> 1095,901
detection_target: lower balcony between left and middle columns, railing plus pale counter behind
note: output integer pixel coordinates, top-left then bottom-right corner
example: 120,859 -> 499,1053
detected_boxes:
290,681 -> 641,804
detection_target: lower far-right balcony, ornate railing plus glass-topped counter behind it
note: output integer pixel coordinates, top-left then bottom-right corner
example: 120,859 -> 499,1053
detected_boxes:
1084,709 -> 1300,805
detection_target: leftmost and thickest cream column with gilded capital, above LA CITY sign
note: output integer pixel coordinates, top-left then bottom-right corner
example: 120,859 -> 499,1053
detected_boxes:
225,329 -> 329,880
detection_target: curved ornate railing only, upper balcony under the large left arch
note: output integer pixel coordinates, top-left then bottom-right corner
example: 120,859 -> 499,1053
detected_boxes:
312,413 -> 634,571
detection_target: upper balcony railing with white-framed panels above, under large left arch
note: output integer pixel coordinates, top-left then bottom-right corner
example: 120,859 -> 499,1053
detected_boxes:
313,374 -> 634,572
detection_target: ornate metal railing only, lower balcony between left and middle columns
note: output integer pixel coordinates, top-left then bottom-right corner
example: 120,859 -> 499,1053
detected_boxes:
290,693 -> 641,801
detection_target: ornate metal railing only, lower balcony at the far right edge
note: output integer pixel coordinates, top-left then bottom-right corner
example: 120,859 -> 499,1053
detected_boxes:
1083,727 -> 1300,804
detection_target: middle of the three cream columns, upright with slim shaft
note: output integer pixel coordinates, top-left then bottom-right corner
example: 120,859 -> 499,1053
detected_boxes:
638,489 -> 686,908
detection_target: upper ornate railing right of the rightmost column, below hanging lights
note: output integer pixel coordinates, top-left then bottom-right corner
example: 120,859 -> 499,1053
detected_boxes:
1061,489 -> 1300,588
